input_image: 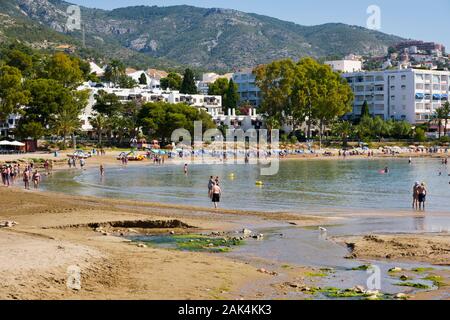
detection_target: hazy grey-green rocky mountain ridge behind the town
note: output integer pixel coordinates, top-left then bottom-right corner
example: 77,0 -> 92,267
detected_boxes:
0,0 -> 404,70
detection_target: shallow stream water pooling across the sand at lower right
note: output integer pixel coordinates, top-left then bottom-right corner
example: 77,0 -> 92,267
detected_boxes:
226,219 -> 450,299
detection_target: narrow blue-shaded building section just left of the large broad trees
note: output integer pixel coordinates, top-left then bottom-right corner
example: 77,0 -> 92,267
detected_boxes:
233,69 -> 261,107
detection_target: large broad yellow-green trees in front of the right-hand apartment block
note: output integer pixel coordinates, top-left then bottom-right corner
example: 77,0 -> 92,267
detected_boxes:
255,58 -> 354,146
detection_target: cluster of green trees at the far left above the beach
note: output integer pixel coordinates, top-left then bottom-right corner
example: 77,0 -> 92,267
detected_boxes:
0,44 -> 90,144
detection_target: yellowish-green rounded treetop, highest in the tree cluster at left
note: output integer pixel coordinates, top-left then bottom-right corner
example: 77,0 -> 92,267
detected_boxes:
46,52 -> 83,89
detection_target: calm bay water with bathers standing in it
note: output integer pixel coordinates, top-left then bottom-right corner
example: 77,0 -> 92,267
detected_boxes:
43,159 -> 450,212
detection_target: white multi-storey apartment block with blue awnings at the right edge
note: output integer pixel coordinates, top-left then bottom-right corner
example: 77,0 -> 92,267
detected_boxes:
343,69 -> 450,124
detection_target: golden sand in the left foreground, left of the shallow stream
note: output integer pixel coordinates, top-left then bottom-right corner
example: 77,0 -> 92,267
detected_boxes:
0,187 -> 326,299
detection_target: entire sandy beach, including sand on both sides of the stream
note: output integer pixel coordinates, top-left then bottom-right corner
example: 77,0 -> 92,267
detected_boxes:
0,152 -> 450,300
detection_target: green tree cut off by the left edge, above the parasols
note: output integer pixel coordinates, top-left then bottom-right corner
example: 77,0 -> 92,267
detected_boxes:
0,66 -> 29,120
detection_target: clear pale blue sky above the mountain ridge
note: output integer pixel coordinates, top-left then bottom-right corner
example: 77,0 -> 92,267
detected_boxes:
68,0 -> 450,51
